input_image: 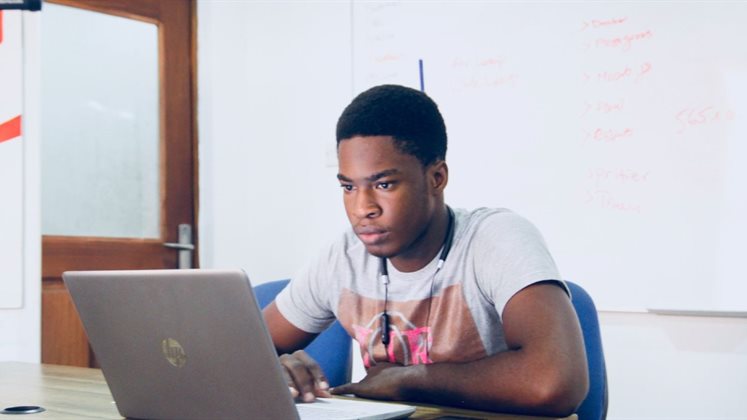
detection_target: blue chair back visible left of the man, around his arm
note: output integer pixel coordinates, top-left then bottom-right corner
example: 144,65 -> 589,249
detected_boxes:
254,280 -> 353,387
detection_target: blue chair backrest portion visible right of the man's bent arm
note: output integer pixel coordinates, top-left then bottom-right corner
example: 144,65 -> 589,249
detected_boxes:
566,281 -> 607,420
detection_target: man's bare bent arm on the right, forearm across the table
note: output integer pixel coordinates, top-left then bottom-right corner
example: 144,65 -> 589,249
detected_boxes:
333,283 -> 588,416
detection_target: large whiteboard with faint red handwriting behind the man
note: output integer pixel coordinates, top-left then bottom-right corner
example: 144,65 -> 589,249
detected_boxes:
351,1 -> 747,311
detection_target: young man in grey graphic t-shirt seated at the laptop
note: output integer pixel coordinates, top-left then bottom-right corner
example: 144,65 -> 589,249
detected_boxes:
264,85 -> 588,416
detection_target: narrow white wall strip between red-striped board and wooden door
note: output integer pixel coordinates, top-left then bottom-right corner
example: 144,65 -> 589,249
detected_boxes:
0,12 -> 41,362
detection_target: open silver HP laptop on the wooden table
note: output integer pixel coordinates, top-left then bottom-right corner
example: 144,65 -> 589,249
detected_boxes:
62,269 -> 415,420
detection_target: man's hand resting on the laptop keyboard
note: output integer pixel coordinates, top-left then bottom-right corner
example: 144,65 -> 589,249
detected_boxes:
280,350 -> 331,402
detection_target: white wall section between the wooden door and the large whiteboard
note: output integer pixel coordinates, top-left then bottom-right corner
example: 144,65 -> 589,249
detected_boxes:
198,2 -> 352,282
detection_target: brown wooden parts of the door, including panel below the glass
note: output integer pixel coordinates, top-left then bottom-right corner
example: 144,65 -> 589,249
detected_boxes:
41,0 -> 199,366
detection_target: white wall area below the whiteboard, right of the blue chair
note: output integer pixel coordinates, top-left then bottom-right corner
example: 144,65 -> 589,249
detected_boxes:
600,312 -> 747,419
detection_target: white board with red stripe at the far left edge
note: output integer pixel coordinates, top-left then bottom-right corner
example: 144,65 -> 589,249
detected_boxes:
0,11 -> 23,308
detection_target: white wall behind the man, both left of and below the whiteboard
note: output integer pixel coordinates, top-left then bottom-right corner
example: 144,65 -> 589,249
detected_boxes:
198,1 -> 747,419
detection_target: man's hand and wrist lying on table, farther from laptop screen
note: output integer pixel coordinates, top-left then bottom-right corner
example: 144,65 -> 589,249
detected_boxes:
332,363 -> 411,400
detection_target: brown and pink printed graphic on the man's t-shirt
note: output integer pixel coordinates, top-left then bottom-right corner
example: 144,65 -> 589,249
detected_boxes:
338,284 -> 487,368
